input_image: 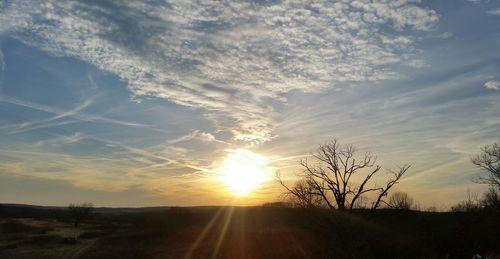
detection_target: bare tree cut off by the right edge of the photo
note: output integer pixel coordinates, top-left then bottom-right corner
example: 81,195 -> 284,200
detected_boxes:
471,143 -> 500,189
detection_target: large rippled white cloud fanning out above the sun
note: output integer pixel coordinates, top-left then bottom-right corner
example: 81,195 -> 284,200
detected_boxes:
0,0 -> 439,143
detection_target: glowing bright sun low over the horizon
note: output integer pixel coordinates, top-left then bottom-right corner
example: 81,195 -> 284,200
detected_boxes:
216,149 -> 272,196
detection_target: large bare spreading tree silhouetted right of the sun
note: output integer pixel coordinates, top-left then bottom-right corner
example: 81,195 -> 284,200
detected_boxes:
277,139 -> 410,210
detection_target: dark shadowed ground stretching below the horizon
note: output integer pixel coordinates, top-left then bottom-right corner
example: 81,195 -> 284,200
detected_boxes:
0,205 -> 500,258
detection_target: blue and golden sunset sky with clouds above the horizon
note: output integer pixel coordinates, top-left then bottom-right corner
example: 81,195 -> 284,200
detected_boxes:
0,0 -> 500,208
